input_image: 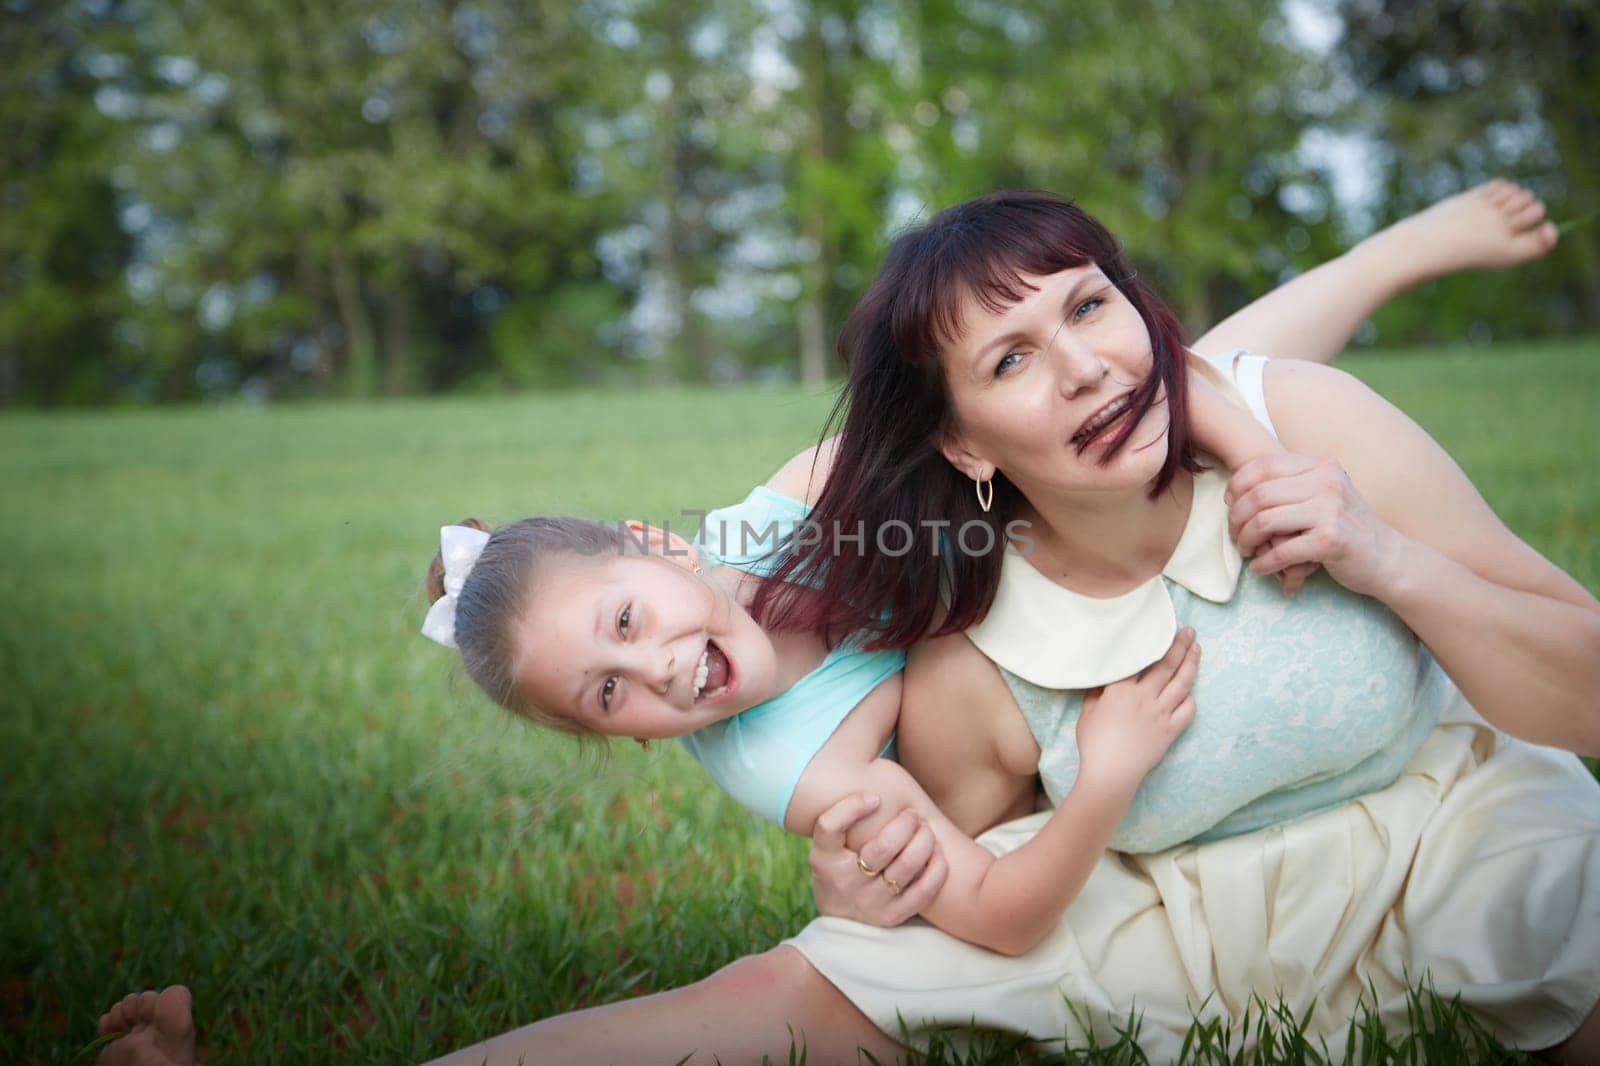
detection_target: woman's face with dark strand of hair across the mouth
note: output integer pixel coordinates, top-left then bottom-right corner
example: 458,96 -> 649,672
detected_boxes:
941,264 -> 1168,498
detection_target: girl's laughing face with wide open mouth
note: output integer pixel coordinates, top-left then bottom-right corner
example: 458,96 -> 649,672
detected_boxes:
514,554 -> 778,739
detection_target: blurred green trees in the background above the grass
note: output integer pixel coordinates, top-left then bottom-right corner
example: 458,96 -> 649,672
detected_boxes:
0,0 -> 1600,405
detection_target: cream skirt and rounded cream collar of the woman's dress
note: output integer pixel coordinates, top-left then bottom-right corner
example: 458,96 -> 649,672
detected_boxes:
789,360 -> 1600,1063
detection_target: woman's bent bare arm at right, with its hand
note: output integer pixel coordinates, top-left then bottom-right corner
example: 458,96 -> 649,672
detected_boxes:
1229,360 -> 1600,755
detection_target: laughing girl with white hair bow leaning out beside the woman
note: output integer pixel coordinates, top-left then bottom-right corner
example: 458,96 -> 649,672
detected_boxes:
424,488 -> 1200,954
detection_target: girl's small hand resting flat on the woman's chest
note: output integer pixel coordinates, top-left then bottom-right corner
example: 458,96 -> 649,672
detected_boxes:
1077,627 -> 1200,792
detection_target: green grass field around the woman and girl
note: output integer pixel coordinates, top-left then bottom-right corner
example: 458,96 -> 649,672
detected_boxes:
0,337 -> 1600,1063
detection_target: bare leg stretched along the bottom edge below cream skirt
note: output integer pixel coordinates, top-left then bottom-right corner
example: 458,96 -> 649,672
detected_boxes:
429,946 -> 904,1066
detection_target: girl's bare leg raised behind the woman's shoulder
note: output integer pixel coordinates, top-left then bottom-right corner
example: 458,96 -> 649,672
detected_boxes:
1194,179 -> 1557,363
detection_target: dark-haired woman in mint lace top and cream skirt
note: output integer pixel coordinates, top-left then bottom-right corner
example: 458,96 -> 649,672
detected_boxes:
774,186 -> 1600,1061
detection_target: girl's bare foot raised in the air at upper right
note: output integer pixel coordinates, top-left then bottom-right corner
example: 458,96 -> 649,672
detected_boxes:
1352,178 -> 1557,285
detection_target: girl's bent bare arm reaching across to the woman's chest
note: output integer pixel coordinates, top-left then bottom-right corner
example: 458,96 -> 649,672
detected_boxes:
795,629 -> 1198,954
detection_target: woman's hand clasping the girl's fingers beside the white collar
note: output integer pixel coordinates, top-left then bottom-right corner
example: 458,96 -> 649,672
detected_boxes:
1224,453 -> 1405,597
